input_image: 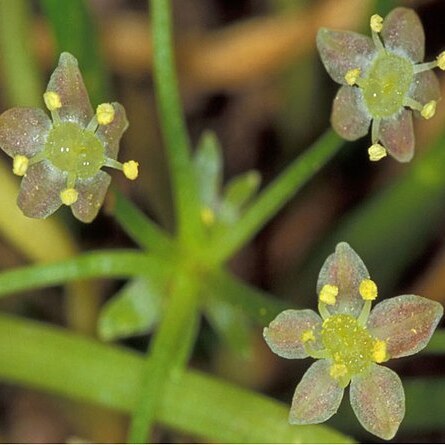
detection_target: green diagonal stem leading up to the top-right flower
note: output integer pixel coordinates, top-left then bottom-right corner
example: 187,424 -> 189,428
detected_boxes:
209,130 -> 343,262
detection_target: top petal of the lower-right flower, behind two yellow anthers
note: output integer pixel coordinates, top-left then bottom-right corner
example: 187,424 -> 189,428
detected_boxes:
317,242 -> 369,316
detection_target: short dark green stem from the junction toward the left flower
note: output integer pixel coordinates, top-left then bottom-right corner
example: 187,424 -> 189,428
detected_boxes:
112,189 -> 175,256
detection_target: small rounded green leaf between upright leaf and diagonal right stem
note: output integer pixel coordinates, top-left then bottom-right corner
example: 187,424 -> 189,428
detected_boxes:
220,170 -> 261,224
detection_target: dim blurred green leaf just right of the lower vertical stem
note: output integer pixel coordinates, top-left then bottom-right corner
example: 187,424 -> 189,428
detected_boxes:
206,298 -> 252,357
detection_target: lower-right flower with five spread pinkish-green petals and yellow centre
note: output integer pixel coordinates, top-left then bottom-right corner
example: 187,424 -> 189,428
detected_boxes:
264,242 -> 443,440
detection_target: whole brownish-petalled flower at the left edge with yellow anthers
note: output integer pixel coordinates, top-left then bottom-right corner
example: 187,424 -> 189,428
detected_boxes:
0,52 -> 138,223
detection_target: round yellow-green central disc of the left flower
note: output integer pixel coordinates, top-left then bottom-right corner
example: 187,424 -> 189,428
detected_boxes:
44,122 -> 105,179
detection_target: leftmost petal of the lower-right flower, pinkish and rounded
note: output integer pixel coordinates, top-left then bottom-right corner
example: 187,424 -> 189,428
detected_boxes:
263,309 -> 321,358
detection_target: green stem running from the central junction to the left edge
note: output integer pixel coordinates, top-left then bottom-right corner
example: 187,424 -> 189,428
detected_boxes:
0,250 -> 165,298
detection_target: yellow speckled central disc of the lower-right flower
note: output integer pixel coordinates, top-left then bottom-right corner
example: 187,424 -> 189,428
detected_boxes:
321,314 -> 375,379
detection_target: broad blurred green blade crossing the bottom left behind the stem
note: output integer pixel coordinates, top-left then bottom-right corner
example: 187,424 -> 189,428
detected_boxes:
0,314 -> 350,443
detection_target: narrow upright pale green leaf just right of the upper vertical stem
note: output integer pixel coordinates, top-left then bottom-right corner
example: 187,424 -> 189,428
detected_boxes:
193,131 -> 223,208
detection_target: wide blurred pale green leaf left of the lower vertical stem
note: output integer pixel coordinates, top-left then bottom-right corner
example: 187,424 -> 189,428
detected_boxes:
98,278 -> 162,341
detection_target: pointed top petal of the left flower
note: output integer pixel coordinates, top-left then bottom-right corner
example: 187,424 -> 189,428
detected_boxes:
46,53 -> 93,126
